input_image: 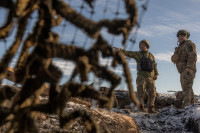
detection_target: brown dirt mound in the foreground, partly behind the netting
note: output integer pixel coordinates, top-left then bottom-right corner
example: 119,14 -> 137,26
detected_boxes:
36,102 -> 139,133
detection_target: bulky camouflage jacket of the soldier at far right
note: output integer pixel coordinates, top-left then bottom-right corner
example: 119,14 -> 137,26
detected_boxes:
171,40 -> 197,73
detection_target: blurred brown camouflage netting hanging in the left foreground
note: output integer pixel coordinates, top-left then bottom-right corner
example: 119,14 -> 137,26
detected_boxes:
0,0 -> 147,133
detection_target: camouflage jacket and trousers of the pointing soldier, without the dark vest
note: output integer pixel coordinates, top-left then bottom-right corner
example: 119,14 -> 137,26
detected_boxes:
122,50 -> 158,107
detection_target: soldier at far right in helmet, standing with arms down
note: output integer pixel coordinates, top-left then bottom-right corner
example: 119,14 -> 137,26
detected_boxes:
171,30 -> 197,106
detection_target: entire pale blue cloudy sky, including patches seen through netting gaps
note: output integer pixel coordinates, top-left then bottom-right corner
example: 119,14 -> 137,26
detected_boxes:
0,0 -> 200,95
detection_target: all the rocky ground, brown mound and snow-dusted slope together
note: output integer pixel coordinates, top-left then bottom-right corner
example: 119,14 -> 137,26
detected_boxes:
0,90 -> 200,133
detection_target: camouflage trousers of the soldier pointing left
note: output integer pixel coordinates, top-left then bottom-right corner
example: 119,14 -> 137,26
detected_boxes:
136,75 -> 156,107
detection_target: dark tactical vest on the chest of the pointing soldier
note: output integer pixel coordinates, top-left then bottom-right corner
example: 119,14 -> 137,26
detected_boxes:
140,54 -> 155,72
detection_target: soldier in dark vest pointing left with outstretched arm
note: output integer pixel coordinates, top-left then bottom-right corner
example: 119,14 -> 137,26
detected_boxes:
115,40 -> 158,113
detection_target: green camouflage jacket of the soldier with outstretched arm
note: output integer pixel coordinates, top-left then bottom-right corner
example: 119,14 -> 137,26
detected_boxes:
121,50 -> 158,78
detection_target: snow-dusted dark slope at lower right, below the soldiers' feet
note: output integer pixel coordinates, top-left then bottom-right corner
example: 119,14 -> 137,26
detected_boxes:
112,94 -> 200,133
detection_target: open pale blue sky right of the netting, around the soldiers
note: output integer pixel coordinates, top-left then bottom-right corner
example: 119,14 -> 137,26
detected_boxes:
134,0 -> 200,95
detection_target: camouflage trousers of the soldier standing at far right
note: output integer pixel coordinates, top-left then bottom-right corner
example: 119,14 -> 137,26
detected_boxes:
180,71 -> 195,106
